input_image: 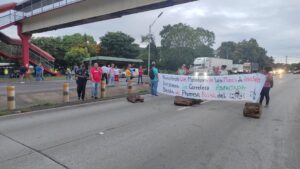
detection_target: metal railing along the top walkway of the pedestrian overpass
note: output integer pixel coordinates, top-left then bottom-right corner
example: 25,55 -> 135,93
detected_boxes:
0,0 -> 82,27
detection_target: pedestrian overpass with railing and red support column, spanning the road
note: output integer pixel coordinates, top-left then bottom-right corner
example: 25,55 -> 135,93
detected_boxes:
0,0 -> 195,70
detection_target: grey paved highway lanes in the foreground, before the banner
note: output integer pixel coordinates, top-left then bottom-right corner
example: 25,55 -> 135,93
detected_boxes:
0,75 -> 300,169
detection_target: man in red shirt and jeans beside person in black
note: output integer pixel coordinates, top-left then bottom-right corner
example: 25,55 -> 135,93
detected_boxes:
90,63 -> 102,99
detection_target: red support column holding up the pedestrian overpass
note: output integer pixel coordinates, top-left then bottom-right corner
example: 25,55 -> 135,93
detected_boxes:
18,24 -> 31,69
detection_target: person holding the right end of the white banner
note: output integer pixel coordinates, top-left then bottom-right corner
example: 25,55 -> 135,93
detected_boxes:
259,67 -> 273,107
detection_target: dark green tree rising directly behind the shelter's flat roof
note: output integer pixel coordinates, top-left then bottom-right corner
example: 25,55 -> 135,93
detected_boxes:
100,32 -> 139,58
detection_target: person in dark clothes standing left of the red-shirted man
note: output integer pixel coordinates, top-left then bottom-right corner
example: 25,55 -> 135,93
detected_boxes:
75,64 -> 89,101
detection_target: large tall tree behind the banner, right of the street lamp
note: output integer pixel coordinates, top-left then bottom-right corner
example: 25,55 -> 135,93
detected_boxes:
160,23 -> 215,70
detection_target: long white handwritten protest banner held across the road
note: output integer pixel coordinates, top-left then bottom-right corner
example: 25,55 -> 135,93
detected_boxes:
157,73 -> 266,102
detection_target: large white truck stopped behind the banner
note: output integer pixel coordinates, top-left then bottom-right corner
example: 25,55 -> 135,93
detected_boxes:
194,57 -> 232,76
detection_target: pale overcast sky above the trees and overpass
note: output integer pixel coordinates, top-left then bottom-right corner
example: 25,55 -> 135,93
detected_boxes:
1,0 -> 300,63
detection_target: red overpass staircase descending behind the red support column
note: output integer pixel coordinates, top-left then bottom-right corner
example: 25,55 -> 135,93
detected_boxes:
0,32 -> 56,75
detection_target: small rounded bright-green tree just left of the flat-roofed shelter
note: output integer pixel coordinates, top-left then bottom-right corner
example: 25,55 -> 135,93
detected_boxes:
64,47 -> 90,66
